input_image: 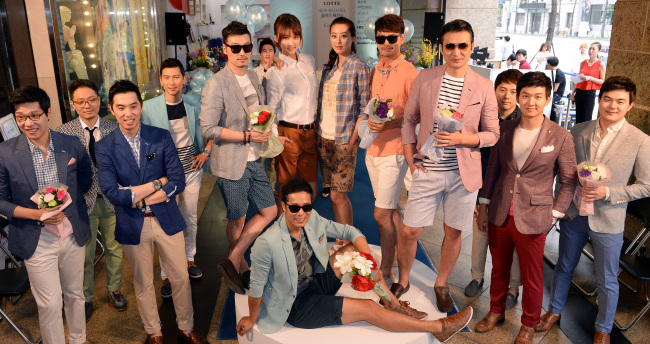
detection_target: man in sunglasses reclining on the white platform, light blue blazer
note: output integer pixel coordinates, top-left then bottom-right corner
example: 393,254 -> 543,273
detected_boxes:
237,179 -> 473,342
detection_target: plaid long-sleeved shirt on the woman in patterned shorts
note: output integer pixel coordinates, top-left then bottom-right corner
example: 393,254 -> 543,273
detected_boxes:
315,53 -> 370,145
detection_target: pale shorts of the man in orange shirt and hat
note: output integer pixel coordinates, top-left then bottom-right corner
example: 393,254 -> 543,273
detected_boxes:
366,154 -> 408,209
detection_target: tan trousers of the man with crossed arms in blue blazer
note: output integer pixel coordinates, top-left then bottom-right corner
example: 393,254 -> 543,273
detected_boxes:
122,217 -> 194,334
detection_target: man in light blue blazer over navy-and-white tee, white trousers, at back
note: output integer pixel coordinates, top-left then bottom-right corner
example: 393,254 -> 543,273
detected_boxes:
141,58 -> 212,297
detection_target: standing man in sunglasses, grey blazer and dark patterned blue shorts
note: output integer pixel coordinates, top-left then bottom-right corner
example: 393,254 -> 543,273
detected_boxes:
199,21 -> 276,294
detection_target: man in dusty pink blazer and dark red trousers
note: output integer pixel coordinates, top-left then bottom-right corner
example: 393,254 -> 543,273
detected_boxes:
476,72 -> 577,343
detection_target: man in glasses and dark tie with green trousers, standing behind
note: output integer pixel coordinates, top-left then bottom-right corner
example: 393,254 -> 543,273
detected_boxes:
56,79 -> 127,322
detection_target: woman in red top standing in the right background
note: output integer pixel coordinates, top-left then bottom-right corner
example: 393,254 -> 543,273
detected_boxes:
571,42 -> 606,124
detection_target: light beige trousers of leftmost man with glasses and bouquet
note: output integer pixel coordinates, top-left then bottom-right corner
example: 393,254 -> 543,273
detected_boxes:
25,229 -> 86,344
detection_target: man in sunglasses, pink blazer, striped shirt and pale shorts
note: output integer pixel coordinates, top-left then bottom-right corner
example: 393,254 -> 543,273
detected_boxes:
397,19 -> 499,312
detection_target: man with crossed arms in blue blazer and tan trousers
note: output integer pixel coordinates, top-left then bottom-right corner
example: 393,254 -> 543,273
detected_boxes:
95,80 -> 205,343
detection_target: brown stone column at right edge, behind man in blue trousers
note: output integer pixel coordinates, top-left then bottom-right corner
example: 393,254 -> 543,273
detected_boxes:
606,0 -> 650,134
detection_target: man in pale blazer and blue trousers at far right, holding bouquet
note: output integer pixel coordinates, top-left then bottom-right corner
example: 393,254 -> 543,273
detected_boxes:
535,76 -> 650,343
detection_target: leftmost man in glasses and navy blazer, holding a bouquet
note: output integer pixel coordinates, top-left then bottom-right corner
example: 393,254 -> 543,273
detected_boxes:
0,86 -> 93,344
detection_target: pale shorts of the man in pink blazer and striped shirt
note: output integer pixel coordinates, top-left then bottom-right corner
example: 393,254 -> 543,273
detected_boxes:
404,168 -> 478,231
